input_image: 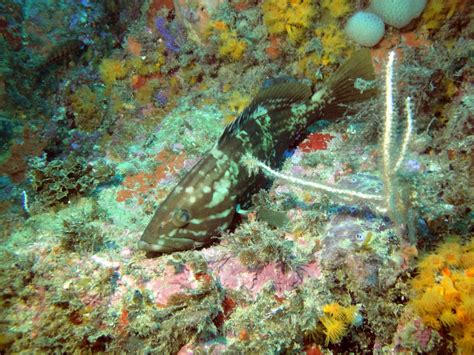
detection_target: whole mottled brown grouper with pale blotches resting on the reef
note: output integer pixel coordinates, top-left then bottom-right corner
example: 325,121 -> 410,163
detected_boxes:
139,49 -> 376,253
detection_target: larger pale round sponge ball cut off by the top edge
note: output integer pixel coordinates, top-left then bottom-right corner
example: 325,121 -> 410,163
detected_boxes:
368,0 -> 426,28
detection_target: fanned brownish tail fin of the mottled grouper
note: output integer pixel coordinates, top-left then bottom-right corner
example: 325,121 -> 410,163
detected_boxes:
313,49 -> 377,119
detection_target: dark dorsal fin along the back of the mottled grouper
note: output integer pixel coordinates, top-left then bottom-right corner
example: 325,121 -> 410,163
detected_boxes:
217,82 -> 312,145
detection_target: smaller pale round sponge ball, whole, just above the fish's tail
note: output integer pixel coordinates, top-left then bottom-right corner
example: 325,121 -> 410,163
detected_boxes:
345,11 -> 385,47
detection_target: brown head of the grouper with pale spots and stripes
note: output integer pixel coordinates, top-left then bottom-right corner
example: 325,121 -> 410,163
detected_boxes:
139,156 -> 235,253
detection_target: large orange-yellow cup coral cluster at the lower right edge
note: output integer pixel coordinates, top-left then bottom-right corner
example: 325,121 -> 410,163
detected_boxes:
410,241 -> 474,353
